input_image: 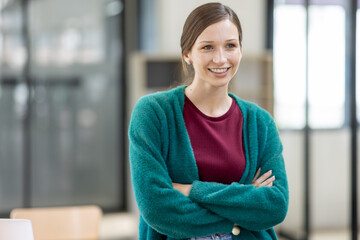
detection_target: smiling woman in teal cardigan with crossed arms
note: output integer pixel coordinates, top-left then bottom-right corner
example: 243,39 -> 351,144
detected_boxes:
129,3 -> 288,240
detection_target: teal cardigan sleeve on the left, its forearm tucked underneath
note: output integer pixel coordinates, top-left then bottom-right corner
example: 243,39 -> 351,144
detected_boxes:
129,96 -> 233,238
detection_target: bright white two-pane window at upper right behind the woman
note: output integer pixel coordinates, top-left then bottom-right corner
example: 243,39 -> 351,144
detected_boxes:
274,5 -> 345,129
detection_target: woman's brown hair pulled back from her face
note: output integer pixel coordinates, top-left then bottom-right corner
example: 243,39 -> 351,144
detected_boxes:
180,2 -> 242,75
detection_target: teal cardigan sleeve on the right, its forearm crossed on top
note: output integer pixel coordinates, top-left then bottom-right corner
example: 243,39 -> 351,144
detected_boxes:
189,113 -> 288,231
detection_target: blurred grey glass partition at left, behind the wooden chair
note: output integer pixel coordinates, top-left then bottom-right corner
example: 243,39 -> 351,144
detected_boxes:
0,0 -> 125,212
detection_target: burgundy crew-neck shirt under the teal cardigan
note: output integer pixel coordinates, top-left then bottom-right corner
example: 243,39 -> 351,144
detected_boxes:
184,96 -> 246,184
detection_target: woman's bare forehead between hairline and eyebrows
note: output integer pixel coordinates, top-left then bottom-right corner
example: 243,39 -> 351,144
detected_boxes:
196,19 -> 239,43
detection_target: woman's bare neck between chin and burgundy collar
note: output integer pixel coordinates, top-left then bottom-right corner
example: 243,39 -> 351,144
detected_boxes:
185,82 -> 232,117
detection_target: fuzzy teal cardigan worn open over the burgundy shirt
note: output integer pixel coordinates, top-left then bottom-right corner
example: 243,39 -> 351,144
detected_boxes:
129,86 -> 289,240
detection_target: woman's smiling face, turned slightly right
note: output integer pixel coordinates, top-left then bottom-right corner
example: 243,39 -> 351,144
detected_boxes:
184,19 -> 242,87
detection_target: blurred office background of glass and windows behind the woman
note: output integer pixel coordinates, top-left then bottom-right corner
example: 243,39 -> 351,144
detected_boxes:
0,0 -> 360,240
